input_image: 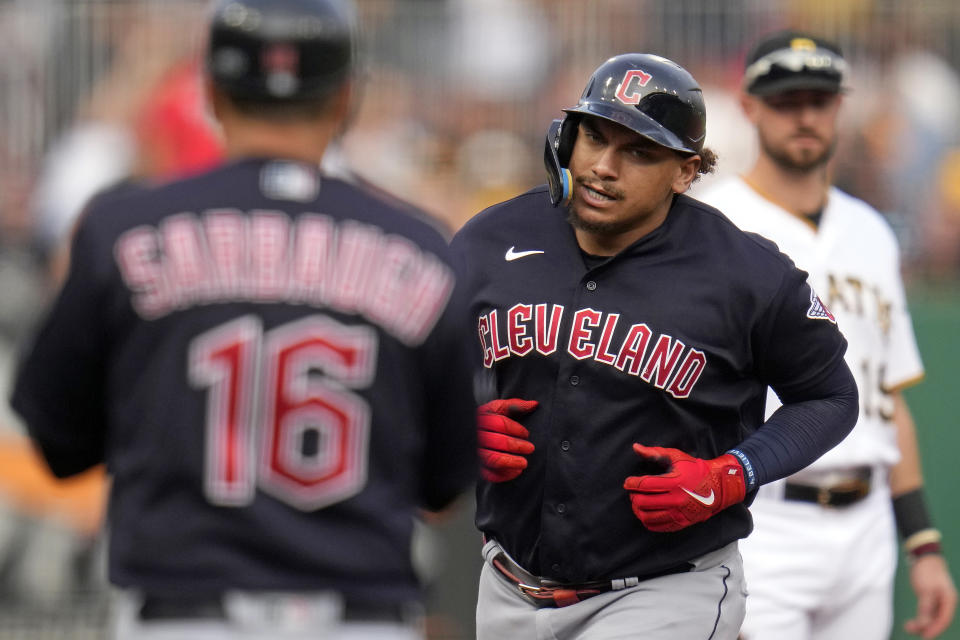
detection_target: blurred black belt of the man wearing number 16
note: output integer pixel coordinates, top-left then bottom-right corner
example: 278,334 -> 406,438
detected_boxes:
139,596 -> 412,623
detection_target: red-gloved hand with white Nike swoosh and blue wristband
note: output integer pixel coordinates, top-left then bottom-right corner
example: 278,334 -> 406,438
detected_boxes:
623,444 -> 747,531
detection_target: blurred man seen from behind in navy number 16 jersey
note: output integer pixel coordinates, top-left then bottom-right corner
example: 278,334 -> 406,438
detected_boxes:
5,0 -> 477,640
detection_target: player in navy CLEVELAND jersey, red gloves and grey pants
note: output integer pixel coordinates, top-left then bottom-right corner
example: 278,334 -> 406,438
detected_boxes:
452,54 -> 857,640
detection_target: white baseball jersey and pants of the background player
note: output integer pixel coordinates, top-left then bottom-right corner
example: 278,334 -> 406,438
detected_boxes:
696,177 -> 923,640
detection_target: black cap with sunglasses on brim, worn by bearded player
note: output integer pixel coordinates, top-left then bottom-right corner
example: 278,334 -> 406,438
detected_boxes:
743,31 -> 847,96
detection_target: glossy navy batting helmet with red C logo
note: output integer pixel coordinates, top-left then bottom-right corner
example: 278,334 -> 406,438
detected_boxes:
544,53 -> 707,204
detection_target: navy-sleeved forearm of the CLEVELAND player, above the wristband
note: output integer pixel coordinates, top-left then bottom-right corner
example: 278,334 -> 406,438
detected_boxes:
736,366 -> 859,488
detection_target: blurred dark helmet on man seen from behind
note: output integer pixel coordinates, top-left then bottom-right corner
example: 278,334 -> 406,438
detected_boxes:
206,0 -> 356,101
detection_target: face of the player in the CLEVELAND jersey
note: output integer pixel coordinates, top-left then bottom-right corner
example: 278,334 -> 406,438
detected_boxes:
568,116 -> 700,255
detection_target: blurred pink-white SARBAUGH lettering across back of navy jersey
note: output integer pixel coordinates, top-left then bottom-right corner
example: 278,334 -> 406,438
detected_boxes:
114,209 -> 454,345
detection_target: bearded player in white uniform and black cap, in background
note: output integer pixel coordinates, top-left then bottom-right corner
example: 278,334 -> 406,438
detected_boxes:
702,31 -> 956,640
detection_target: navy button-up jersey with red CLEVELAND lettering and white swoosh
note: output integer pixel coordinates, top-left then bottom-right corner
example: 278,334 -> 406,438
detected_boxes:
452,187 -> 846,582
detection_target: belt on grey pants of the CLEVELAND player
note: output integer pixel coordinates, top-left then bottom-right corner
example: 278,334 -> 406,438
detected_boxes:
490,551 -> 693,609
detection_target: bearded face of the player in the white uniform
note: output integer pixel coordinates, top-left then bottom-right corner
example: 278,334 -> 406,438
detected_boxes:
745,90 -> 841,173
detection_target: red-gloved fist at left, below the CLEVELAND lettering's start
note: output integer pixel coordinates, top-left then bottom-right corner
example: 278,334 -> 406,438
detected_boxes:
477,398 -> 538,482
